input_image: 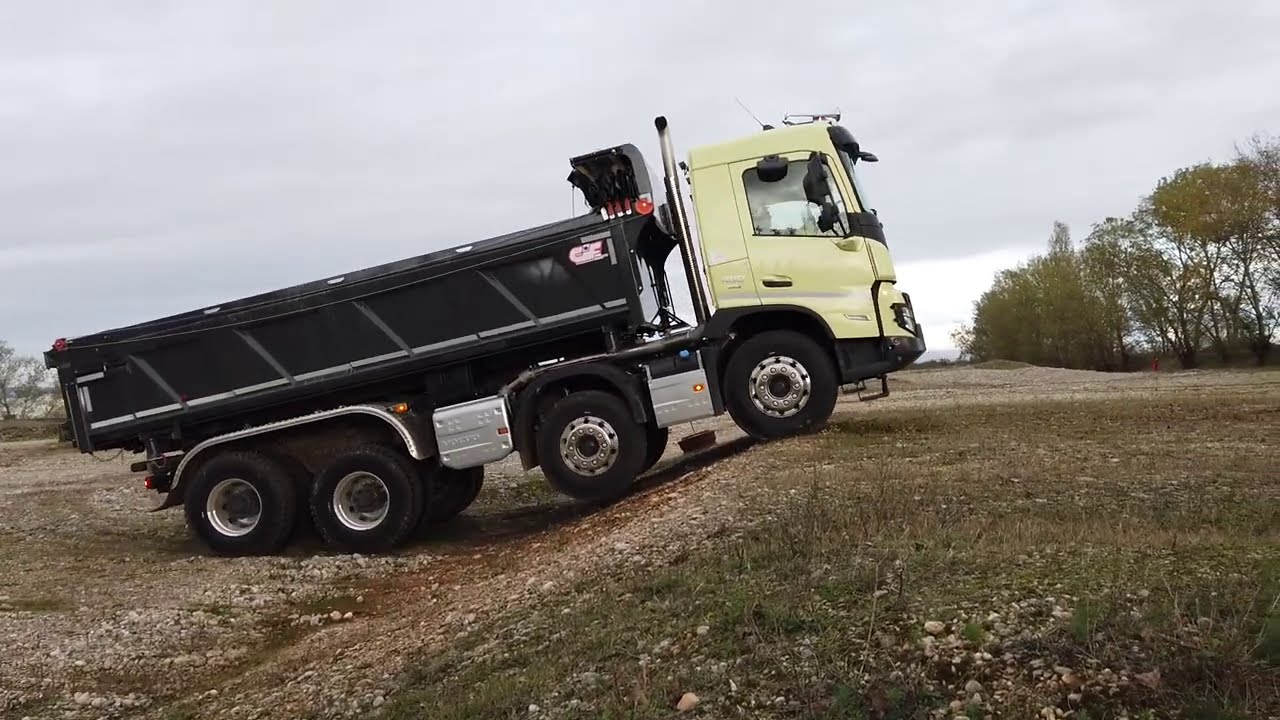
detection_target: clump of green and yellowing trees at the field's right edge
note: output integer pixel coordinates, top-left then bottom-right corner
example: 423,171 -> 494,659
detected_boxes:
954,130 -> 1280,369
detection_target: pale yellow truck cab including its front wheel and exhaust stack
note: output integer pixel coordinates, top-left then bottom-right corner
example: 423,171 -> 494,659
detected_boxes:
657,115 -> 925,438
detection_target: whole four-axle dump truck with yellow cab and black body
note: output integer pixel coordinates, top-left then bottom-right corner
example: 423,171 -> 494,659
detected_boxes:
45,115 -> 925,555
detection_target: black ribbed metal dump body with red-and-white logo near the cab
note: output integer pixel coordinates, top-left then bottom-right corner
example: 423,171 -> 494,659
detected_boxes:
45,196 -> 672,452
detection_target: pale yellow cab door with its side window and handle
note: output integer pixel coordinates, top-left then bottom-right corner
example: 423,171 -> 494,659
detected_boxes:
730,151 -> 879,338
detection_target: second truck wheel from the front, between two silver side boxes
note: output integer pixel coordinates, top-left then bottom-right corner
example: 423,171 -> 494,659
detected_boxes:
538,391 -> 649,501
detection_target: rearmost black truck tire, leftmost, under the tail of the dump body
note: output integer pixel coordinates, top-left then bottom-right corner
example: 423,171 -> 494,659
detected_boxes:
184,451 -> 298,556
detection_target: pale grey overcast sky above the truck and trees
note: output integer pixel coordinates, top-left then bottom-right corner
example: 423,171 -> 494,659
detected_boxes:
0,0 -> 1280,354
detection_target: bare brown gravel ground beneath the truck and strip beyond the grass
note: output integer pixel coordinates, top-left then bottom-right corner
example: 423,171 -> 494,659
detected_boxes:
0,368 -> 1280,719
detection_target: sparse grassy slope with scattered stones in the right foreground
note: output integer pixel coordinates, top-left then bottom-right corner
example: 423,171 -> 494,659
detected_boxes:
375,393 -> 1280,720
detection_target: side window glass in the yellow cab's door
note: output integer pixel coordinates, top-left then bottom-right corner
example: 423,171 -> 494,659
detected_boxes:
742,158 -> 845,237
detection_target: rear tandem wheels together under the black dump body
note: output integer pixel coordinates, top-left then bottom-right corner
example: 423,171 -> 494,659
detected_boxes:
186,445 -> 484,556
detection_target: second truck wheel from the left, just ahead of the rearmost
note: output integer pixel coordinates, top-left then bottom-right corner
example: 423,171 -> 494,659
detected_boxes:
308,445 -> 424,553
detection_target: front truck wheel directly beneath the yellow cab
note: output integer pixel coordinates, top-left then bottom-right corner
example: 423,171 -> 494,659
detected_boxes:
723,331 -> 840,441
